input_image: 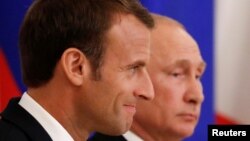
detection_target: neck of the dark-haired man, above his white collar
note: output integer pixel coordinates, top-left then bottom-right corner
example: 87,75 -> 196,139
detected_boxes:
28,89 -> 90,141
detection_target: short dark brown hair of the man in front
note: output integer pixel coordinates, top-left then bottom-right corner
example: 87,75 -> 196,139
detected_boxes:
19,0 -> 154,87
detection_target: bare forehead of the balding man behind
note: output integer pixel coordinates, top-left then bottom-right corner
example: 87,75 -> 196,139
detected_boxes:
151,25 -> 203,63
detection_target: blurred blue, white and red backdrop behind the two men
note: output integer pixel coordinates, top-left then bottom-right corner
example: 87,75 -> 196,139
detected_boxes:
0,0 -> 250,141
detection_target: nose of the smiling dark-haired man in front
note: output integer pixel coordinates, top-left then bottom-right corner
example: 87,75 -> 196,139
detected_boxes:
134,70 -> 155,100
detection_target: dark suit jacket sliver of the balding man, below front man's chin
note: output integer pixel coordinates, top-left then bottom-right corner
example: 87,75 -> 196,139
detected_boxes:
88,133 -> 127,141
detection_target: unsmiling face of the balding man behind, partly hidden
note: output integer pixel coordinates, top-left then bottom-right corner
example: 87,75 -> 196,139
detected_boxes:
135,20 -> 205,139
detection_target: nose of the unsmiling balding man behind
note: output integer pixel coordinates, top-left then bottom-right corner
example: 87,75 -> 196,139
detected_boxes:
184,79 -> 205,105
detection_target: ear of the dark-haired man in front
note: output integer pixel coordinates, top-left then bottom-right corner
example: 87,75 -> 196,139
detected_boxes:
61,48 -> 87,86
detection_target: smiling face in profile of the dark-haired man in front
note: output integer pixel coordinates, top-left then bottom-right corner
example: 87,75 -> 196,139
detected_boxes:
81,15 -> 154,135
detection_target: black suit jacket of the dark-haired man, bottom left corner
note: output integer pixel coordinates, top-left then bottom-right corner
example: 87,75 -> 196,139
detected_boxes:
0,98 -> 52,141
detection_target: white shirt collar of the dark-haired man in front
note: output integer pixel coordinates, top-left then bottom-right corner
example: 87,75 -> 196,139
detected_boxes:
19,92 -> 74,141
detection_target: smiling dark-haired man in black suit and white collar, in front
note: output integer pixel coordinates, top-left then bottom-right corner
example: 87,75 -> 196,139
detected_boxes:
0,0 -> 154,141
